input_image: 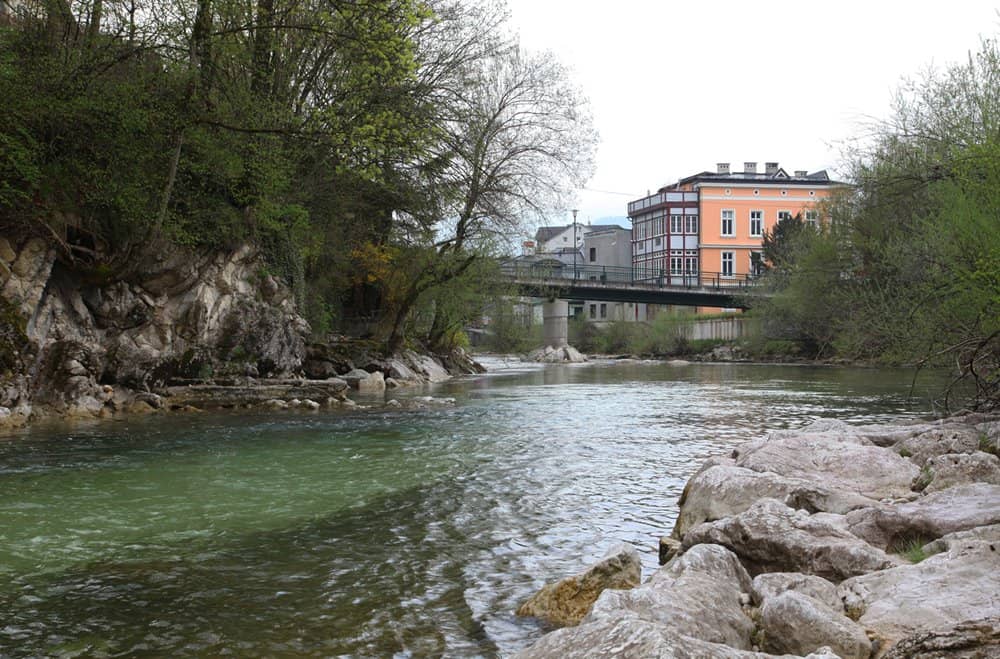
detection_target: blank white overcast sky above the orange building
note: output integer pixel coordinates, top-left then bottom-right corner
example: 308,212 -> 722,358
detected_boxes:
508,0 -> 1000,223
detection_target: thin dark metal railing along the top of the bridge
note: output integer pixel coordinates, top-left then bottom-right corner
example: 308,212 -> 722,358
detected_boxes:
500,261 -> 757,290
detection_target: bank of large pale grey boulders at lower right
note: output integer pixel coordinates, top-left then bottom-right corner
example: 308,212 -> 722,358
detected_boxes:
517,415 -> 1000,659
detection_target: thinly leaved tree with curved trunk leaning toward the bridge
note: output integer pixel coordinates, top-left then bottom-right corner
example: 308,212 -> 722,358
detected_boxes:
376,40 -> 596,351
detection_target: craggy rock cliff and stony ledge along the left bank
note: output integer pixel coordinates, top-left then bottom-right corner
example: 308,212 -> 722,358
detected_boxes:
0,237 -> 482,428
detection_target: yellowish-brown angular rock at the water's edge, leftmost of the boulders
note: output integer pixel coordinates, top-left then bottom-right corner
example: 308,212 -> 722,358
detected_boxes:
517,544 -> 642,626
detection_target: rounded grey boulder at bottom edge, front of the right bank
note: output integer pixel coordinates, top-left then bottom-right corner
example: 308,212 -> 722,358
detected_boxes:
760,590 -> 872,659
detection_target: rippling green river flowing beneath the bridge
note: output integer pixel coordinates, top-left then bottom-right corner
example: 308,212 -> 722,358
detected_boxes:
0,360 -> 929,657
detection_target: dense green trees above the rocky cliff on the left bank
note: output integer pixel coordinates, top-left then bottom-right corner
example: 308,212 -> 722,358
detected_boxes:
0,0 -> 595,356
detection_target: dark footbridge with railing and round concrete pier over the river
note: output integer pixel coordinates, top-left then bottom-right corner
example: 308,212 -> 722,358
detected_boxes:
500,260 -> 761,346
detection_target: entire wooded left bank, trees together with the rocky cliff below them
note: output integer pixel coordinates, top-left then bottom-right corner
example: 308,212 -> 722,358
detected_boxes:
0,0 -> 595,421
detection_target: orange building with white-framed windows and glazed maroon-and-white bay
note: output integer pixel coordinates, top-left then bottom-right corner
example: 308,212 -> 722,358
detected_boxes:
628,162 -> 844,296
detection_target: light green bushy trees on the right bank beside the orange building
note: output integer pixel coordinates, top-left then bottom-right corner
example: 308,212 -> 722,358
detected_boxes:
758,40 -> 1000,410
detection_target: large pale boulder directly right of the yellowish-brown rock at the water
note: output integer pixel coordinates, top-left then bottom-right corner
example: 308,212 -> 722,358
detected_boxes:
584,545 -> 754,650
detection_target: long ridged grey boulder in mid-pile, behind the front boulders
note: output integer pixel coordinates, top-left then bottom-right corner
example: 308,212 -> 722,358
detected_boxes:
683,499 -> 894,582
